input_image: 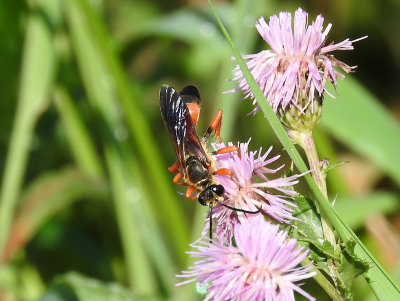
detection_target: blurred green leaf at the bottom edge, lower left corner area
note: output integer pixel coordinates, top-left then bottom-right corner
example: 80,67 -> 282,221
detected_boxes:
40,272 -> 138,301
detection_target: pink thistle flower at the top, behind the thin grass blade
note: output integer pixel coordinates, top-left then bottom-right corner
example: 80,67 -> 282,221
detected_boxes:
227,8 -> 366,113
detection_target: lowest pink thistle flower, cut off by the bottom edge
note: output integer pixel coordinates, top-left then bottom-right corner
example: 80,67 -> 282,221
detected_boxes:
177,218 -> 315,301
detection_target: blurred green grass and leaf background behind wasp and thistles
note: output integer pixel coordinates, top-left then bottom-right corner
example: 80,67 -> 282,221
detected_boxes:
0,0 -> 400,301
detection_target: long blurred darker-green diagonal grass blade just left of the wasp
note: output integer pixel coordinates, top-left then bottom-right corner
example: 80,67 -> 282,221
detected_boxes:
80,0 -> 189,263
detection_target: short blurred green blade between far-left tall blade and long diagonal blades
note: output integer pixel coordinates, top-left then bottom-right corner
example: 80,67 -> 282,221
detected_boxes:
54,87 -> 103,177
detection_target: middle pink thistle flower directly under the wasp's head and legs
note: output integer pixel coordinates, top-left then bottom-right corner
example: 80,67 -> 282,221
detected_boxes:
203,140 -> 301,241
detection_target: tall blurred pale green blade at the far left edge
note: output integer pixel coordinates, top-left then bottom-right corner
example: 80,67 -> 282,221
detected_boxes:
0,0 -> 58,252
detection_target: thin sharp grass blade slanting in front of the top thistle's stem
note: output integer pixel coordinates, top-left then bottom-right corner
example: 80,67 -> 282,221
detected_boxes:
208,0 -> 400,300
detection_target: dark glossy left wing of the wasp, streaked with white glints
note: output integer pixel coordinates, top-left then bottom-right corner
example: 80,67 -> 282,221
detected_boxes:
160,85 -> 209,168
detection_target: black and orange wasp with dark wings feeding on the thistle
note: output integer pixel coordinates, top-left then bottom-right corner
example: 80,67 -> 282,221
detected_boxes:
160,85 -> 259,234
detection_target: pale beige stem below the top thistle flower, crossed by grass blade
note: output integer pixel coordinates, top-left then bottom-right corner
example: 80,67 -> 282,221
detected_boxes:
288,130 -> 337,250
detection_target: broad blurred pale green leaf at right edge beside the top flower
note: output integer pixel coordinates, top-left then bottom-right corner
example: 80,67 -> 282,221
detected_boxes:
321,76 -> 400,185
